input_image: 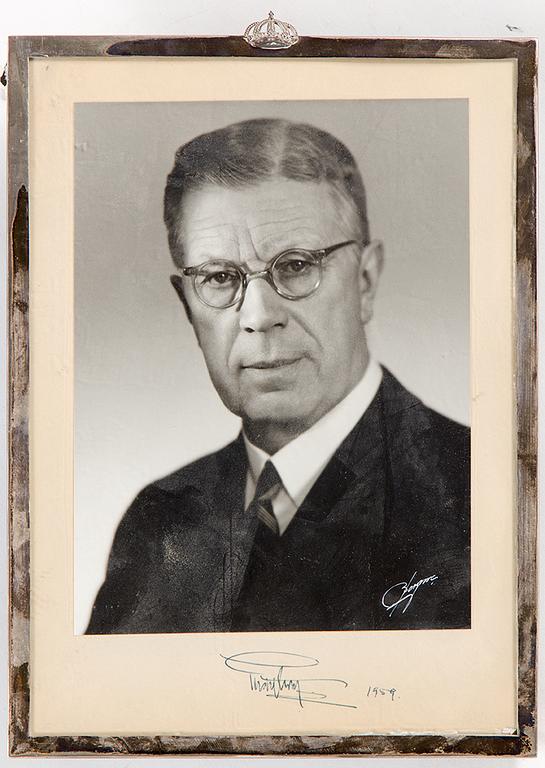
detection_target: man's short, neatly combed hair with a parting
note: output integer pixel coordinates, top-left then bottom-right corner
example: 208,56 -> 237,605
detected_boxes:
164,118 -> 369,265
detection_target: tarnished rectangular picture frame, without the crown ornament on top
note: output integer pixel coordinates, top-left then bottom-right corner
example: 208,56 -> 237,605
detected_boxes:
8,37 -> 537,756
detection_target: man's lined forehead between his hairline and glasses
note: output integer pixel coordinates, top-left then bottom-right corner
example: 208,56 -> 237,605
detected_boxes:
176,179 -> 350,263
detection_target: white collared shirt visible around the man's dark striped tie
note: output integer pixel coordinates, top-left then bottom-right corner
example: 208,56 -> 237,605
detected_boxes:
244,358 -> 382,534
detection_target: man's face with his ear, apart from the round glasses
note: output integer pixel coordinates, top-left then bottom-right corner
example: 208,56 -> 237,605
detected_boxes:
176,179 -> 380,434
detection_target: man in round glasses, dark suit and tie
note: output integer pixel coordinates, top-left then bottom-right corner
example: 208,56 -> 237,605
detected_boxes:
87,119 -> 470,634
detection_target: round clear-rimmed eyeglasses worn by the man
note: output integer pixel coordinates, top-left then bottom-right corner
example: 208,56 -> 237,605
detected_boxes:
176,240 -> 358,309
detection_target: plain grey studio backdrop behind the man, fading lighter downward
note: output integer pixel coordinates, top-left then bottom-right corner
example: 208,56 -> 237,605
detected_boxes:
74,99 -> 469,633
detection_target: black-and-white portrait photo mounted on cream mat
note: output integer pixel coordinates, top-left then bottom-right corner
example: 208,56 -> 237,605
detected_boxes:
74,99 -> 471,635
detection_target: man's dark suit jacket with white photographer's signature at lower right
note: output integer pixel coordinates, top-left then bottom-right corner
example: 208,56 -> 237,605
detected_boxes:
87,370 -> 470,634
